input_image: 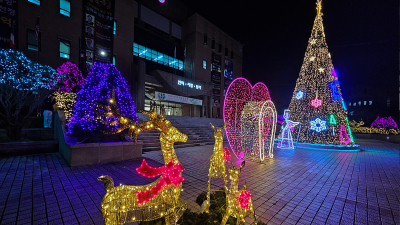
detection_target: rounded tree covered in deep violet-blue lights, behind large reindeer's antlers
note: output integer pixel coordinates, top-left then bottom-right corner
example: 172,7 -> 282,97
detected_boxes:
67,62 -> 138,135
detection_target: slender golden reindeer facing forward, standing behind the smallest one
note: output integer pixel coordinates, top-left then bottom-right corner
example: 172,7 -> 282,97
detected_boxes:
200,123 -> 229,213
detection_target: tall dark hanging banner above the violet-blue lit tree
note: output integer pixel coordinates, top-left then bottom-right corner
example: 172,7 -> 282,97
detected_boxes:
82,0 -> 115,72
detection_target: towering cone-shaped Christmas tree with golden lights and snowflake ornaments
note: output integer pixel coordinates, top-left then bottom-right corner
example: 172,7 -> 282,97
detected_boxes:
289,0 -> 354,145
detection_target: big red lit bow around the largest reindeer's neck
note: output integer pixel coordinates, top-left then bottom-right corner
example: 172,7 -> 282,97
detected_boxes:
136,159 -> 185,205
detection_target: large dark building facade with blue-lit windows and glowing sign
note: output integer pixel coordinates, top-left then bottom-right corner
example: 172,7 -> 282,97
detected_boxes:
7,0 -> 243,118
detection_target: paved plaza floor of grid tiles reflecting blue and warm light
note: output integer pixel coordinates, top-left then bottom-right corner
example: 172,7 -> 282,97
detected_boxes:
0,140 -> 400,225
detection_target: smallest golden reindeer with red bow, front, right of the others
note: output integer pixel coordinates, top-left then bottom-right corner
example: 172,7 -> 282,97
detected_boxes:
221,161 -> 257,225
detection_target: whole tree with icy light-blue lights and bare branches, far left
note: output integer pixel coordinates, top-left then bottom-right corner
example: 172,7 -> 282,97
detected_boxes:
0,49 -> 64,140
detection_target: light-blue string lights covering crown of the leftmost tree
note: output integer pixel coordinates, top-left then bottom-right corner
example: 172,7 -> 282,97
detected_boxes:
0,49 -> 65,91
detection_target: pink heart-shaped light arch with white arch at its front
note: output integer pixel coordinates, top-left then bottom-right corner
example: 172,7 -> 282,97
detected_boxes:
223,78 -> 277,161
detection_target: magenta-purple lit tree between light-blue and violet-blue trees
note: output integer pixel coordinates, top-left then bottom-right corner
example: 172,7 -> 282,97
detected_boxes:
57,62 -> 84,92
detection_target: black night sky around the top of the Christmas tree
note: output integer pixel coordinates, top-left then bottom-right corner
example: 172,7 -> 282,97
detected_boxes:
182,0 -> 399,113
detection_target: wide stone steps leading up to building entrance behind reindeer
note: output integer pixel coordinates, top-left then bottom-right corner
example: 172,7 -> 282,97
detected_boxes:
138,126 -> 219,152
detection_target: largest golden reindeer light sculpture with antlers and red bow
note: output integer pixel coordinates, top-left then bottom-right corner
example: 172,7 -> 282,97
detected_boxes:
97,101 -> 187,225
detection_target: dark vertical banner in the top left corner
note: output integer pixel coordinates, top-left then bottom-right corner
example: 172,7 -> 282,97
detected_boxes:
0,0 -> 18,49
